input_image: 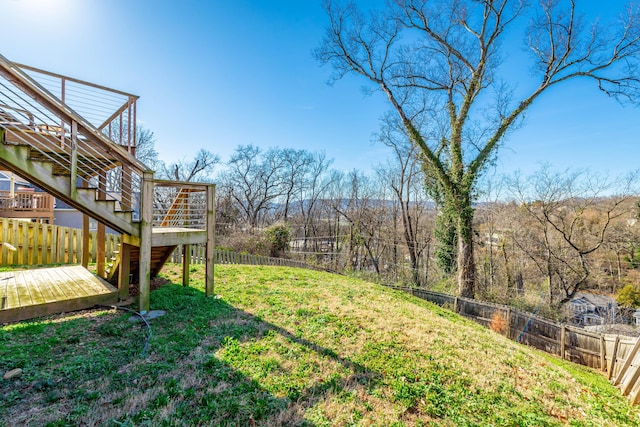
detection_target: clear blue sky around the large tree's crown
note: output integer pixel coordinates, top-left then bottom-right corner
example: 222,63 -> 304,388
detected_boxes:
0,0 -> 640,175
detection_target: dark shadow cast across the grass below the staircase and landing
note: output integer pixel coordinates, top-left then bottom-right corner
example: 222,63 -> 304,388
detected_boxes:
0,285 -> 376,426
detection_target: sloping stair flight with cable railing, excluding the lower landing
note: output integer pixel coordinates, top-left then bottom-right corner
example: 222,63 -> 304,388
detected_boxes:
0,55 -> 147,236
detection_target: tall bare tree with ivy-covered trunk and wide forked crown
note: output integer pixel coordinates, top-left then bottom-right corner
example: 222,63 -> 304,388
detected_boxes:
314,0 -> 640,297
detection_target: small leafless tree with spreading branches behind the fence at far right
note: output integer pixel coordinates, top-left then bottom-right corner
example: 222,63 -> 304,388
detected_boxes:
509,166 -> 637,305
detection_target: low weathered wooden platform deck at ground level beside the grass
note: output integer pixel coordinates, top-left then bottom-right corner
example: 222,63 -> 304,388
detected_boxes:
0,266 -> 118,323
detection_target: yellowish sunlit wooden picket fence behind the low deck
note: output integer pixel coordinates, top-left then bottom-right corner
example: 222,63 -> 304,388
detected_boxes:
0,218 -> 120,265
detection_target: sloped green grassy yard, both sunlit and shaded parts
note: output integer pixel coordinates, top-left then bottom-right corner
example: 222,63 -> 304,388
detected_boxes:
0,266 -> 640,426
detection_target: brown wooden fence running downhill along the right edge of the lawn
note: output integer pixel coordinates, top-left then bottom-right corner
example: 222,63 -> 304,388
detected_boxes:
391,286 -> 640,404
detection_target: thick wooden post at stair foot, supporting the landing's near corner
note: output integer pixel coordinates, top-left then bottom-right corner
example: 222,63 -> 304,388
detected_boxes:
139,171 -> 153,314
